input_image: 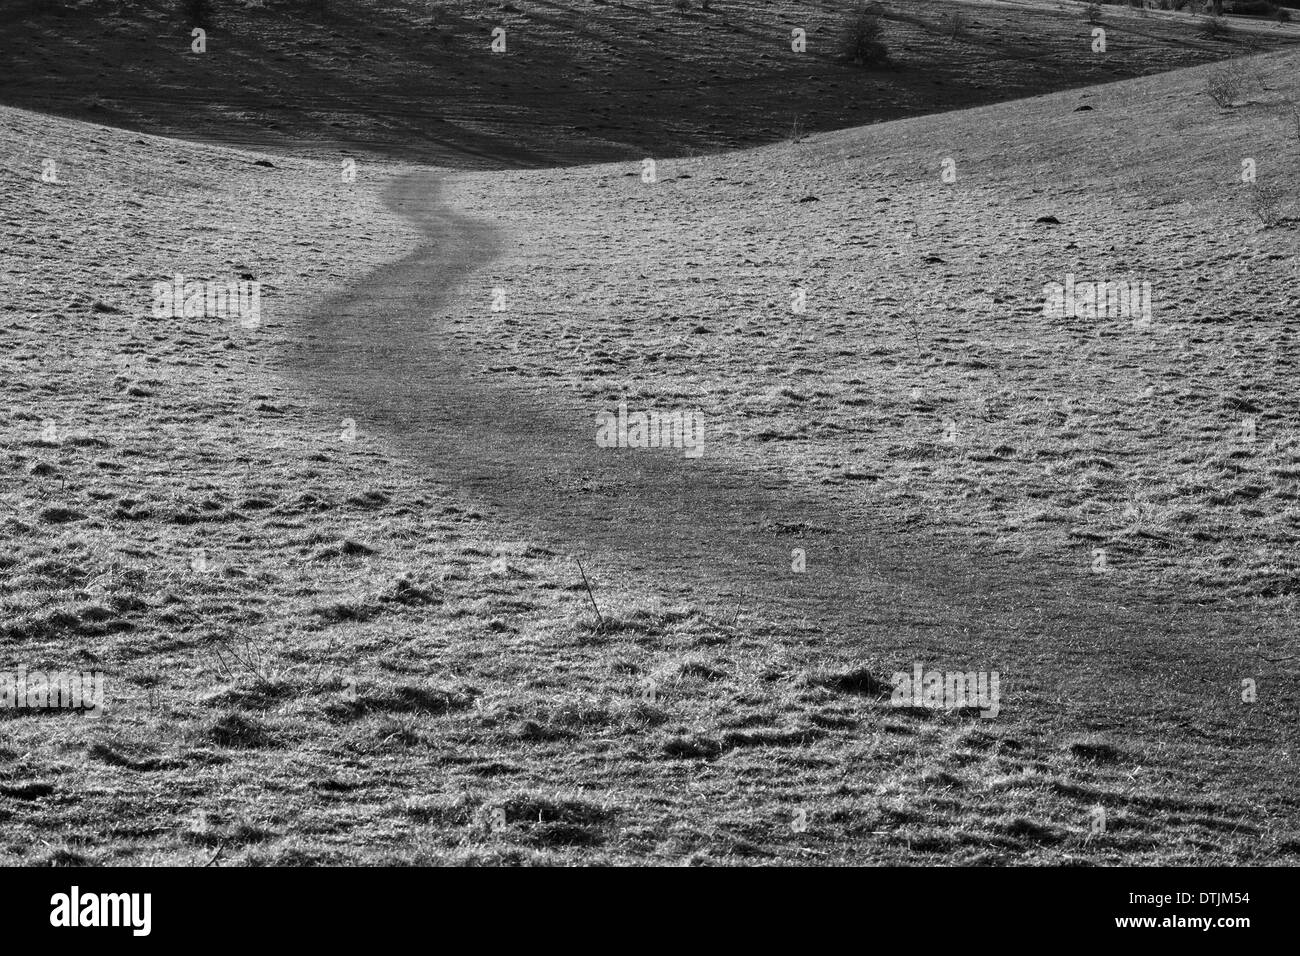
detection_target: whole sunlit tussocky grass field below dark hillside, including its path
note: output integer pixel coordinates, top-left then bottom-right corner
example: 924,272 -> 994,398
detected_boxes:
0,4 -> 1300,865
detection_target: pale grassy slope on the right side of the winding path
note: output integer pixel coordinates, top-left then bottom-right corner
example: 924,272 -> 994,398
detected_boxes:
452,44 -> 1300,601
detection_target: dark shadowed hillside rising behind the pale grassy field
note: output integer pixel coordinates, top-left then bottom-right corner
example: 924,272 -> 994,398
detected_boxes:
0,0 -> 1300,166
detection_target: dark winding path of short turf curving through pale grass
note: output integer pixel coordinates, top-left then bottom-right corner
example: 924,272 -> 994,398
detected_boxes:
289,170 -> 1279,727
